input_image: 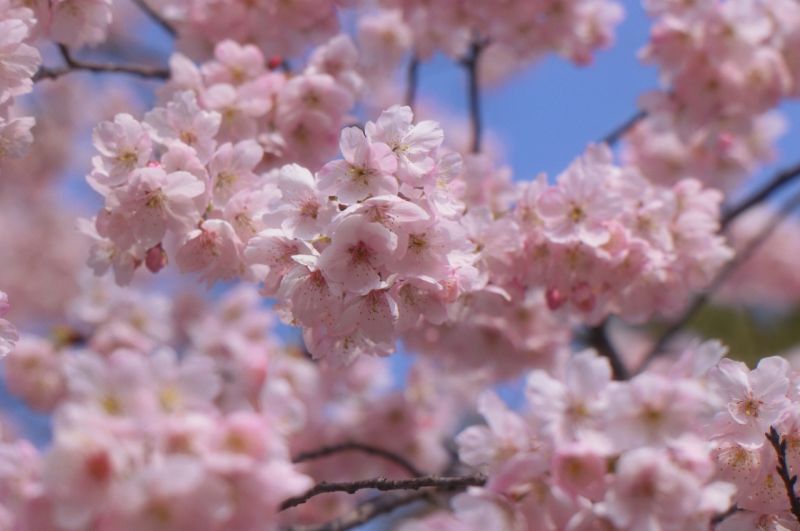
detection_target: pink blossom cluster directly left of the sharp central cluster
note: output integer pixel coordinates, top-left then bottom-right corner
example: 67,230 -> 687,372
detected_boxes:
83,37 -> 359,284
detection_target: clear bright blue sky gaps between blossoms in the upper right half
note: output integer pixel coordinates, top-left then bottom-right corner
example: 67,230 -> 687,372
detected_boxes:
420,0 -> 800,201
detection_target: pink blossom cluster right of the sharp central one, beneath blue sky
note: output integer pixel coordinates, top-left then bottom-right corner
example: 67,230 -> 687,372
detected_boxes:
460,145 -> 732,323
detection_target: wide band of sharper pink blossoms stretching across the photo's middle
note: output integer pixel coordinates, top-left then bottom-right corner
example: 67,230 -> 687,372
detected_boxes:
84,64 -> 730,366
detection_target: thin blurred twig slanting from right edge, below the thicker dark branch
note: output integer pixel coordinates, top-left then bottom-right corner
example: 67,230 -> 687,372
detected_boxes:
636,189 -> 800,373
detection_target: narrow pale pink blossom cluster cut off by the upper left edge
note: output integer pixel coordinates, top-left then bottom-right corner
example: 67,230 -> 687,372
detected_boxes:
0,0 -> 42,161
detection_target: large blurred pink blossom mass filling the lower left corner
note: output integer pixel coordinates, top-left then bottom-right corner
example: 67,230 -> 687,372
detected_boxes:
0,281 -> 466,530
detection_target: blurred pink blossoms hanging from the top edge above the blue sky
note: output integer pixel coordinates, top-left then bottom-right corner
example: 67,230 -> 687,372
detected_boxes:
381,0 -> 623,64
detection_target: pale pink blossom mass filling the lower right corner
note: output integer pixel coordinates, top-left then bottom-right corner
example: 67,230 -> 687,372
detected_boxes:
400,342 -> 800,531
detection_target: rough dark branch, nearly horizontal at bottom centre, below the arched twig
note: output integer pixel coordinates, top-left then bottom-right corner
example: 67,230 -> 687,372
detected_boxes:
280,475 -> 486,510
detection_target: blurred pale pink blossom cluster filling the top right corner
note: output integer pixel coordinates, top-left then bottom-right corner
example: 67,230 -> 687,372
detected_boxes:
627,0 -> 800,189
